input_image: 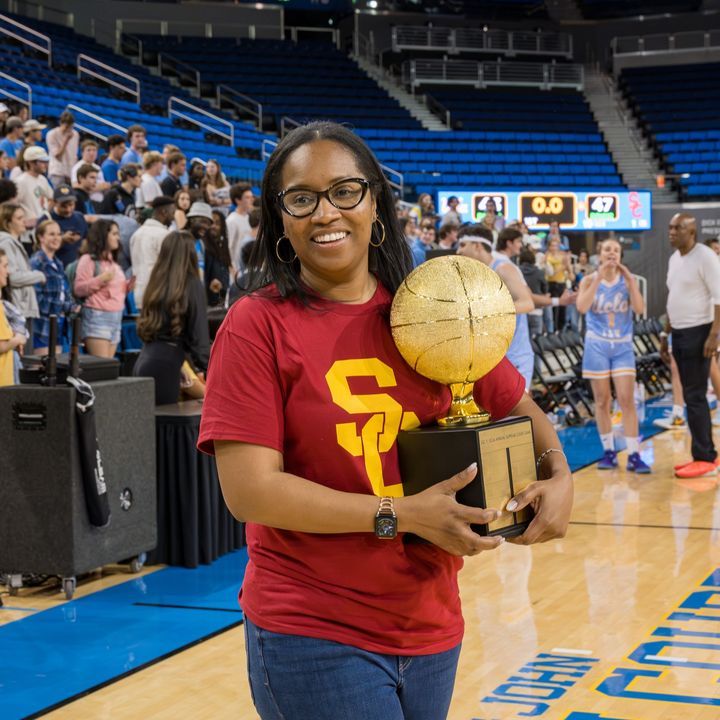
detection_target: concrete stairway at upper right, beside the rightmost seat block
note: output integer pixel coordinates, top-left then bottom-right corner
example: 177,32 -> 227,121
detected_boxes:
585,65 -> 678,203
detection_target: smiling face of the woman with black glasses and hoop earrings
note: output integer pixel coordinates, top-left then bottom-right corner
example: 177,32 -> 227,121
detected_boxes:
282,140 -> 376,289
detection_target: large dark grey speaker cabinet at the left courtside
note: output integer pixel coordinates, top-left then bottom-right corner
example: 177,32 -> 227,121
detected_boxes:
0,378 -> 157,577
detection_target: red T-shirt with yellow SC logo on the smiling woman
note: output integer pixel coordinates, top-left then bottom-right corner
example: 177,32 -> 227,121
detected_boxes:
199,286 -> 525,655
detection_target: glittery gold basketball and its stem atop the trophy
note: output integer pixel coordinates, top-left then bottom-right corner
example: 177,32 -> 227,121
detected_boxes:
390,255 -> 515,424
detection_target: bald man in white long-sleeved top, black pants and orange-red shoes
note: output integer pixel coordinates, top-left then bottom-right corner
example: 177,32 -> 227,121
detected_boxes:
661,213 -> 720,478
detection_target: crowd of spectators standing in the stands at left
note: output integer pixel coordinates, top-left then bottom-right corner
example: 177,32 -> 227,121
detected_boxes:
0,103 -> 259,395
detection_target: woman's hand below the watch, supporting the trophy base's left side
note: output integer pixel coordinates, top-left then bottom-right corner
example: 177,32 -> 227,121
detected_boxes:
395,463 -> 504,556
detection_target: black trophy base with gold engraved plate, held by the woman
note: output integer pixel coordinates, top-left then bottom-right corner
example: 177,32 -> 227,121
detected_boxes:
398,416 -> 537,537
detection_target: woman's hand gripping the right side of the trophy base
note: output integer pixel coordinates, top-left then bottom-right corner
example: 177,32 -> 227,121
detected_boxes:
507,469 -> 573,545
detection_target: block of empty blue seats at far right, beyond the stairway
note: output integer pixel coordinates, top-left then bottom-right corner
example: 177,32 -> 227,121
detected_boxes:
620,63 -> 720,199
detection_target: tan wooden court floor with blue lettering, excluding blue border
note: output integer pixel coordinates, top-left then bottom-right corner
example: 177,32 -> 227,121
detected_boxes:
5,424 -> 720,720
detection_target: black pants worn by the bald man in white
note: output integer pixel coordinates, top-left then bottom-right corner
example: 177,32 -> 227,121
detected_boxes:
672,323 -> 717,462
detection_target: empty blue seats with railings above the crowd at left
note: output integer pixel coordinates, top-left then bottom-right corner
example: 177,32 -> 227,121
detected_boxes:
0,13 -> 269,182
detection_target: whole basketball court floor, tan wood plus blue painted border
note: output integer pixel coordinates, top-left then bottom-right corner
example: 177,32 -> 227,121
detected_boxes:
0,407 -> 720,720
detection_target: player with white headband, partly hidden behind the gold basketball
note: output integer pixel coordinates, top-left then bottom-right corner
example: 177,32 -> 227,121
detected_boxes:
457,223 -> 535,390
